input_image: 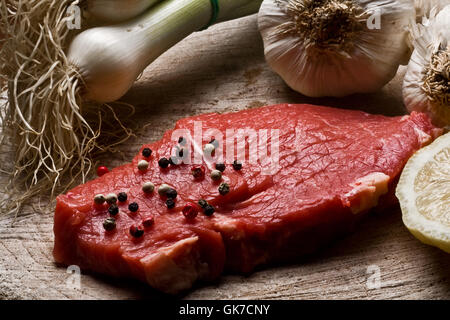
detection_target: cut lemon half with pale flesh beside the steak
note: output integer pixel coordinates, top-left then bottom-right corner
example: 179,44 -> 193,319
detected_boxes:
396,133 -> 450,253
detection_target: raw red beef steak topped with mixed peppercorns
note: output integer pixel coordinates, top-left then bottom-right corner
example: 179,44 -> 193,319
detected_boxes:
54,104 -> 440,293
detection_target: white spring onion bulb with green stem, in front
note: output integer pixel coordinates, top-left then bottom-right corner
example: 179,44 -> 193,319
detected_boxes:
68,0 -> 262,102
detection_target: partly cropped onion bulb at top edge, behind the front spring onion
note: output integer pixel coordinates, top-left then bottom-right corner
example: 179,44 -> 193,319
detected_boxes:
85,0 -> 162,23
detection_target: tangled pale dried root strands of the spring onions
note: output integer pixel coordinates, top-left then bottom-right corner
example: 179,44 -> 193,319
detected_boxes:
0,0 -> 134,213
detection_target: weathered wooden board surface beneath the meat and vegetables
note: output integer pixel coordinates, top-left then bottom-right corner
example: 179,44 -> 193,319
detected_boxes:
0,16 -> 450,299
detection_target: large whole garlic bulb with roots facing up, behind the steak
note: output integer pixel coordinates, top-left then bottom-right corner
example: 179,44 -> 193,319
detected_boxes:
258,0 -> 415,97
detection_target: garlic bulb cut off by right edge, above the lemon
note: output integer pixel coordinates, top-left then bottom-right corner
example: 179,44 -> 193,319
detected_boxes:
403,5 -> 450,127
